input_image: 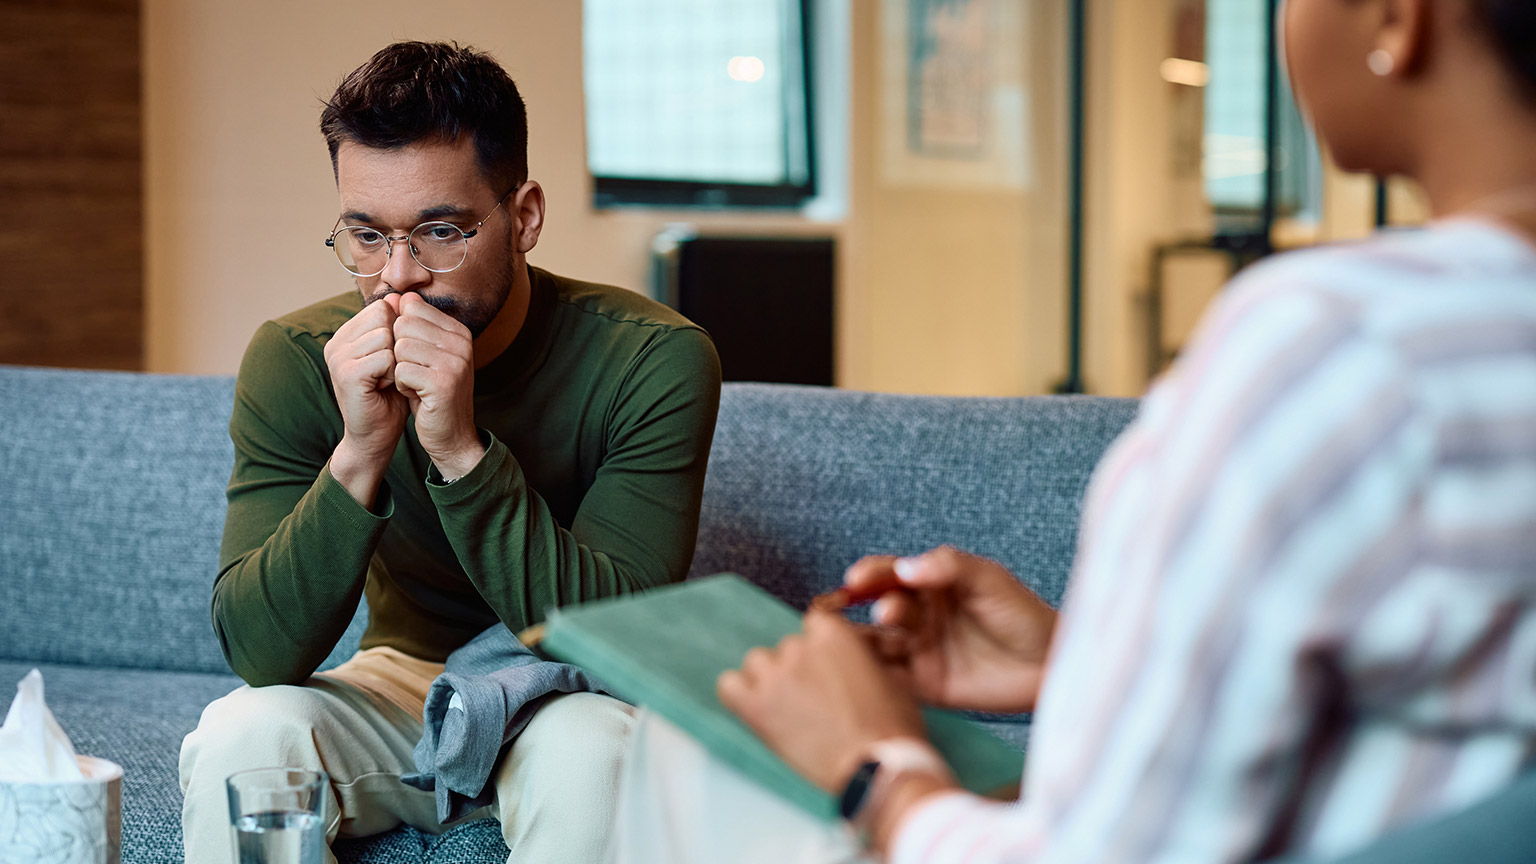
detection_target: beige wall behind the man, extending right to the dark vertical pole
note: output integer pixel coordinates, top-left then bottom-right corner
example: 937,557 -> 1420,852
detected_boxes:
144,0 -> 1064,394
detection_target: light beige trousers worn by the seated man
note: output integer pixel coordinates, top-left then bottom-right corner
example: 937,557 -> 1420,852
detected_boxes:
180,647 -> 634,864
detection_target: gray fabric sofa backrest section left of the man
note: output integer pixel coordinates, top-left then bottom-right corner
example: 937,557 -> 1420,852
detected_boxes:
0,366 -> 362,672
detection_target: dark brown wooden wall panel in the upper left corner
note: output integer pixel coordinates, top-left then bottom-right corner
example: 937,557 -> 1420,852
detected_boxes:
0,0 -> 144,369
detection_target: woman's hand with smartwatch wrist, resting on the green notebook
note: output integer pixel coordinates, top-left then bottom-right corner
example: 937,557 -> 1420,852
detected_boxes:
716,610 -> 926,793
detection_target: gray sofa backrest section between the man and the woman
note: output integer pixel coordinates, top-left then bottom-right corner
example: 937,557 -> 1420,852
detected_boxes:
690,384 -> 1137,606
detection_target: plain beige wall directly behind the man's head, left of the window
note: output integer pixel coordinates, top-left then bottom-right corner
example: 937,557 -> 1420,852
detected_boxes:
144,0 -> 835,374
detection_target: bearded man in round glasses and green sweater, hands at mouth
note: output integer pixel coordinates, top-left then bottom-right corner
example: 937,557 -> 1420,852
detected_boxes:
181,43 -> 720,864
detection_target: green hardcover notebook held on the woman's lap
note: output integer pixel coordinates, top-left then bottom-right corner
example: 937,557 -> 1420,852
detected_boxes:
541,573 -> 1025,819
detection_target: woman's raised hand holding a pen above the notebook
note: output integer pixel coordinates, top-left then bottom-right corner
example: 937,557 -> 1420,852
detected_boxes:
845,546 -> 1057,713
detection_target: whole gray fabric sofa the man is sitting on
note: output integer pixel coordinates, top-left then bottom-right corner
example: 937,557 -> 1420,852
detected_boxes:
0,366 -> 1536,864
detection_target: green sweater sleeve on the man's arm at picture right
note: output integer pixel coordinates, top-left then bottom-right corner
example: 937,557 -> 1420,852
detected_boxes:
427,327 -> 720,629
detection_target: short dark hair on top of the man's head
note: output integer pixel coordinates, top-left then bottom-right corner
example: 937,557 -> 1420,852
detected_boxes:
319,42 -> 528,192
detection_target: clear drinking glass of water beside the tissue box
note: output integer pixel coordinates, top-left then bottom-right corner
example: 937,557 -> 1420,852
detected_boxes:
226,769 -> 330,864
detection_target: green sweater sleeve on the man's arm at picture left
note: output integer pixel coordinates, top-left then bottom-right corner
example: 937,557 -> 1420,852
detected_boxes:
212,321 -> 392,687
